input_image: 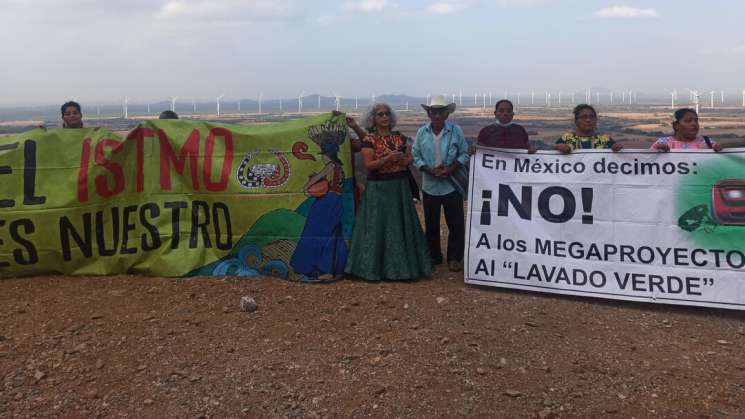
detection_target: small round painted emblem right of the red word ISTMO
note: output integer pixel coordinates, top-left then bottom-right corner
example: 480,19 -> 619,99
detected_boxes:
236,150 -> 290,189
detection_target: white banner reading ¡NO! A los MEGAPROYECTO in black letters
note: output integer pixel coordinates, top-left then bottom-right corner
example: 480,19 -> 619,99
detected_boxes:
465,148 -> 745,309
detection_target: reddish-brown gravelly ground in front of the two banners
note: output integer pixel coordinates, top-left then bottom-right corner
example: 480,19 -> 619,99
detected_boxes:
0,269 -> 745,418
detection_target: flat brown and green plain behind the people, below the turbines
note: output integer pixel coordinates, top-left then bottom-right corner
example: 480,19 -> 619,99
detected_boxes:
5,105 -> 745,148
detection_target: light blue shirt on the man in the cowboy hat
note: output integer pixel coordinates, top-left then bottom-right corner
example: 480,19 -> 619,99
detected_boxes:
411,121 -> 468,196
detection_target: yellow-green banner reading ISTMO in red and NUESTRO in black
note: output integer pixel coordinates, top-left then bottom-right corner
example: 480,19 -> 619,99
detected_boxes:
0,114 -> 354,280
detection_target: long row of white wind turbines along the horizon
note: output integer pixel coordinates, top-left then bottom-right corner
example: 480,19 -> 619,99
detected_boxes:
113,88 -> 745,119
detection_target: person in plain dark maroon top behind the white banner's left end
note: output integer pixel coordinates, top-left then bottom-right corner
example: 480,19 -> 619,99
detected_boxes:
480,99 -> 537,154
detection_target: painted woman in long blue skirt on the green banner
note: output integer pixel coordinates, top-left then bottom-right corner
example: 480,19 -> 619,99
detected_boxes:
290,124 -> 347,281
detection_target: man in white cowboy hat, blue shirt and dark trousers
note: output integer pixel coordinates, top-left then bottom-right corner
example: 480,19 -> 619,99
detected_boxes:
412,95 -> 468,272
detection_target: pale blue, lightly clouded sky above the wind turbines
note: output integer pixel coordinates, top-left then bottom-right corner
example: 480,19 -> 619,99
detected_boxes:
0,0 -> 745,106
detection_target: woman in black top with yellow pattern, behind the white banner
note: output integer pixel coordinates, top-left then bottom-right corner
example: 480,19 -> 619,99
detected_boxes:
554,104 -> 623,154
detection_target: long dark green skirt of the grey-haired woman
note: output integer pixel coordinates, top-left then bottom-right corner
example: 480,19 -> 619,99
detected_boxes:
344,178 -> 432,281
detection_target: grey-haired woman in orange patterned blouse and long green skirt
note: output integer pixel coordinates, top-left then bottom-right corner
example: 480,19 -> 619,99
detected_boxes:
344,103 -> 432,281
